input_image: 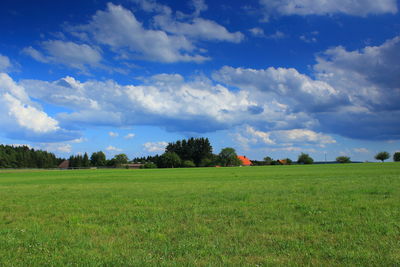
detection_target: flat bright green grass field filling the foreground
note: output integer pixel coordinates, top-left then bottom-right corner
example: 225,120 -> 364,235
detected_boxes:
0,163 -> 400,266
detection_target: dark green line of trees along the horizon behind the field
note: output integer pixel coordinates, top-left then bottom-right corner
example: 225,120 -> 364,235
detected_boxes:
0,142 -> 400,168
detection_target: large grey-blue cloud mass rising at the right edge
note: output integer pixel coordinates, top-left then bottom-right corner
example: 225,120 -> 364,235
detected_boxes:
314,37 -> 400,140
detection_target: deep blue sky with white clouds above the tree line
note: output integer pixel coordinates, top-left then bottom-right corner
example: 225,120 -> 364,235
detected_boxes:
0,0 -> 400,161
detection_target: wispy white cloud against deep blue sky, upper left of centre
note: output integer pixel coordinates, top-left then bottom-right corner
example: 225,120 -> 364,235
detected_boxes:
72,3 -> 207,62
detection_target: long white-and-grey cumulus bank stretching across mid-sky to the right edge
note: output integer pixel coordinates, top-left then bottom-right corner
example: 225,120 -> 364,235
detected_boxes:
8,37 -> 400,142
